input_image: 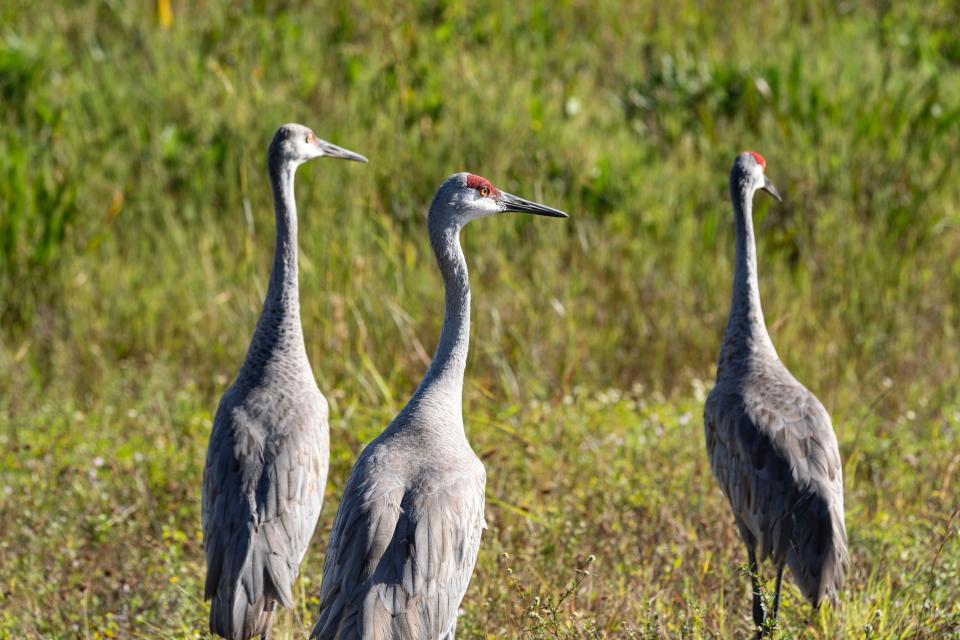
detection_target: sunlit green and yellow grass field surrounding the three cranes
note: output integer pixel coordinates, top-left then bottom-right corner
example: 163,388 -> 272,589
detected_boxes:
0,0 -> 960,639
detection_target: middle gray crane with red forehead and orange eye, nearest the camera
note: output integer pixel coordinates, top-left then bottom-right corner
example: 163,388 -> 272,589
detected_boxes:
311,173 -> 567,640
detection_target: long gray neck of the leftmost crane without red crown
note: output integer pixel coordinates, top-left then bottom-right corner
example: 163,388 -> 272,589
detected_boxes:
238,154 -> 306,376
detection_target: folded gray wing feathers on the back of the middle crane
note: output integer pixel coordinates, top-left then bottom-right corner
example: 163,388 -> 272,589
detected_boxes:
311,450 -> 485,640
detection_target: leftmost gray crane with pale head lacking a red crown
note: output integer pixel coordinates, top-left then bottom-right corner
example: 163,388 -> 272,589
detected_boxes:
202,124 -> 367,640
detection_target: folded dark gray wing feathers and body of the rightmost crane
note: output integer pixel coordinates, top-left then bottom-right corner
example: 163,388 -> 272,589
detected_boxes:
704,374 -> 847,606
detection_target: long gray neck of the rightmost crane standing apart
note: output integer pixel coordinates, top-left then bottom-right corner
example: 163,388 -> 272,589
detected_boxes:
717,178 -> 776,376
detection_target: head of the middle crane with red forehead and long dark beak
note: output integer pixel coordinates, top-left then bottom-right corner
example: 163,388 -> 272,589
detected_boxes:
431,172 -> 568,226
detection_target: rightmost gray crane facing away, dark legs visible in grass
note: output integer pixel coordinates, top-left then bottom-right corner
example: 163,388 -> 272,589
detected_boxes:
703,151 -> 848,637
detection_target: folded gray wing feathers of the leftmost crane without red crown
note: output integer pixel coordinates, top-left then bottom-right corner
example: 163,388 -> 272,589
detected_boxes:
202,392 -> 327,639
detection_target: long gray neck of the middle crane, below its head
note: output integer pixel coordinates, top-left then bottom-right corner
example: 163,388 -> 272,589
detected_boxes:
407,212 -> 470,433
